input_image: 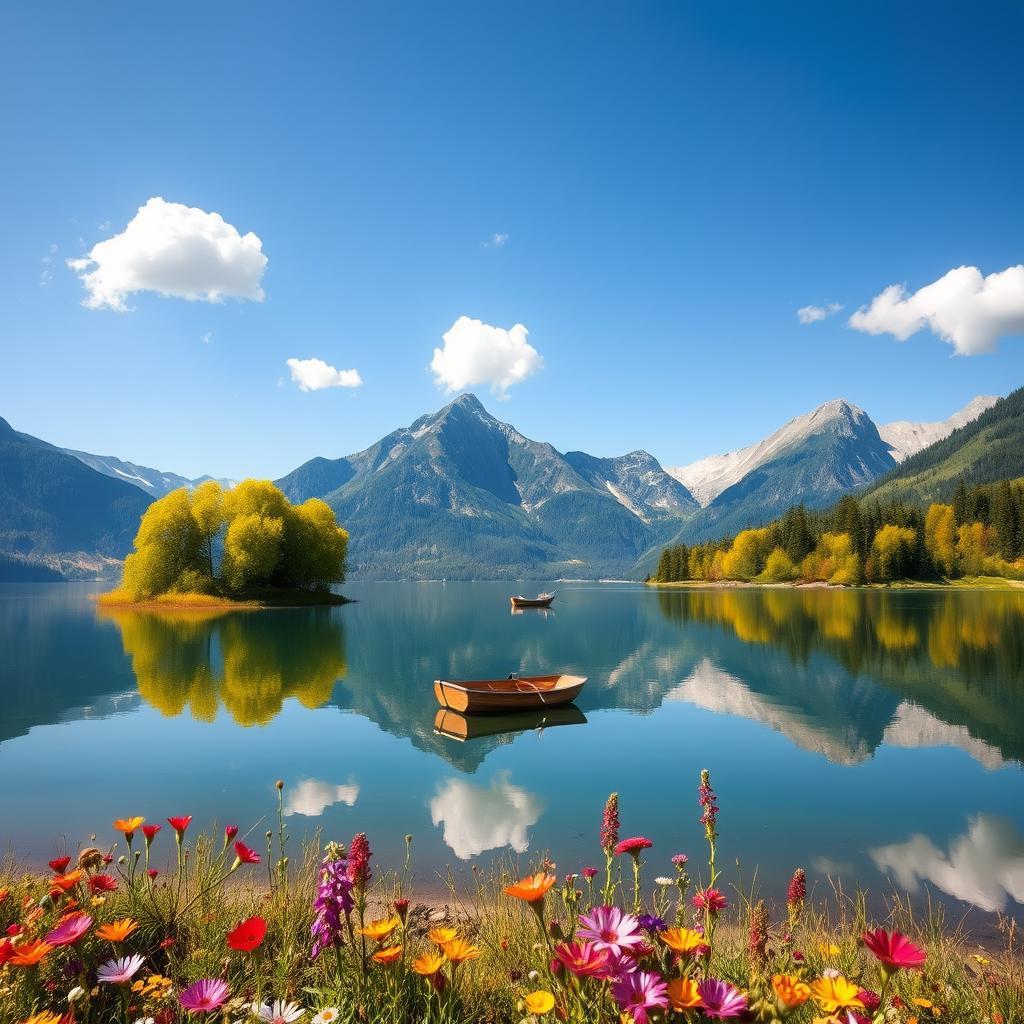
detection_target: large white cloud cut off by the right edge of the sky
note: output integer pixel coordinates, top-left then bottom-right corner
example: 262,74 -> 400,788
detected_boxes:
850,265 -> 1024,355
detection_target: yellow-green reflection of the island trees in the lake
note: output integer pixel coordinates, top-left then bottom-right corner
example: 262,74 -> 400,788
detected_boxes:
100,608 -> 346,726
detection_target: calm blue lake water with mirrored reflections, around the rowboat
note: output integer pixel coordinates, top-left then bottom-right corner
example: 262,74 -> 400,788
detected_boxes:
0,584 -> 1024,912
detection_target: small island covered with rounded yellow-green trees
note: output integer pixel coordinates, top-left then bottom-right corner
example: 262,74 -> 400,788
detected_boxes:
97,480 -> 348,610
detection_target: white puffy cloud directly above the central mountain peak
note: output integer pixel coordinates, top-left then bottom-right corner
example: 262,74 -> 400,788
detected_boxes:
430,316 -> 544,398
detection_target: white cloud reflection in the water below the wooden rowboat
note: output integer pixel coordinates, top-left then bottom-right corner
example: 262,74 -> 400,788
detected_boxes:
430,771 -> 544,860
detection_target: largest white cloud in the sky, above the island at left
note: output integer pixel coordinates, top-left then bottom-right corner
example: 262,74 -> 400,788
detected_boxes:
68,197 -> 267,312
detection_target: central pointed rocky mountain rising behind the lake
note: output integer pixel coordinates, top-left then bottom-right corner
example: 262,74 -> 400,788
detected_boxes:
276,394 -> 697,579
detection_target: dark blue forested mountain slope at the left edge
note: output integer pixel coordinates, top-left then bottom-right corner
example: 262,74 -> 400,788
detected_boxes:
0,419 -> 151,574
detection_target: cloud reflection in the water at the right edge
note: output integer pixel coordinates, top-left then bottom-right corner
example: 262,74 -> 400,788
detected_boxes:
867,814 -> 1024,911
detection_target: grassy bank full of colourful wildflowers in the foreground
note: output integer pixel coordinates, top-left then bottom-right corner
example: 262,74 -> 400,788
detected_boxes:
0,776 -> 1024,1024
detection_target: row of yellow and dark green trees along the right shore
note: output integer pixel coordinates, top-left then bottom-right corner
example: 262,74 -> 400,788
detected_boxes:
653,480 -> 1024,586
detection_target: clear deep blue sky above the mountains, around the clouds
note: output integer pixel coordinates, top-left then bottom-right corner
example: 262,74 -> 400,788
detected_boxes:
0,2 -> 1024,476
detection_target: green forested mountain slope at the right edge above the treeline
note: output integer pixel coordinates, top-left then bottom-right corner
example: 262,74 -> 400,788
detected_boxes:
865,388 -> 1024,502
